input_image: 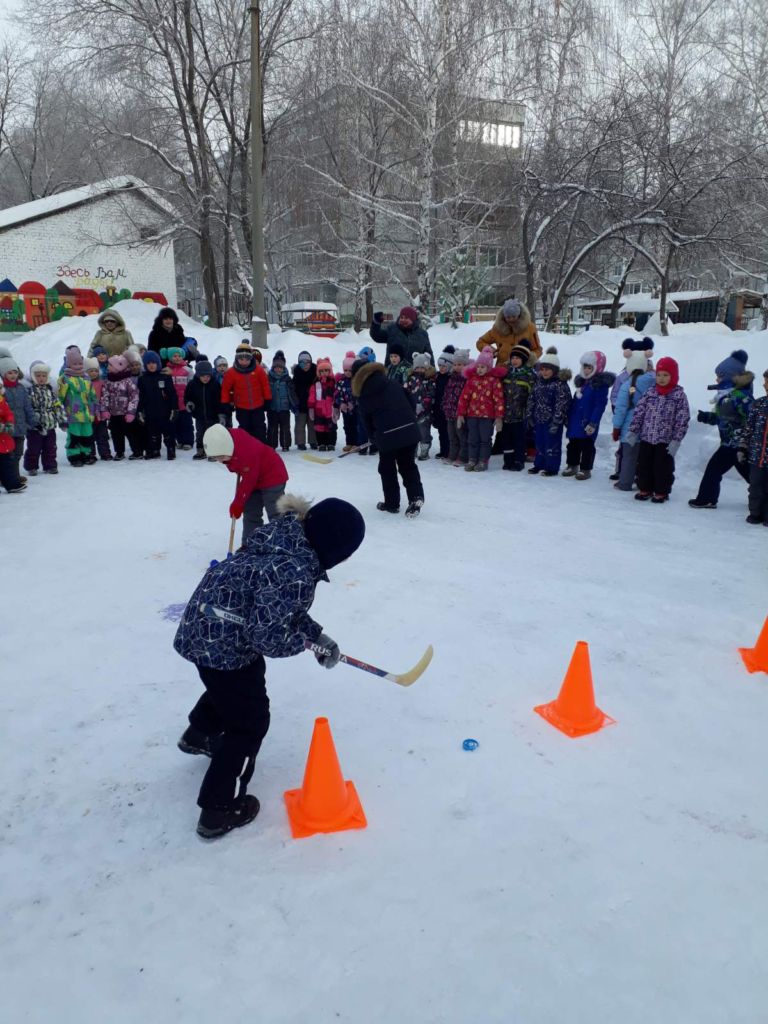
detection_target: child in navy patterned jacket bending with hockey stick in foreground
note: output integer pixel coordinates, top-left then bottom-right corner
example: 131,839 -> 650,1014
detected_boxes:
173,495 -> 366,839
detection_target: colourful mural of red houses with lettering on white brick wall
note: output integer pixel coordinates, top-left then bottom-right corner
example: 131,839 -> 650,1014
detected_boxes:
0,276 -> 168,334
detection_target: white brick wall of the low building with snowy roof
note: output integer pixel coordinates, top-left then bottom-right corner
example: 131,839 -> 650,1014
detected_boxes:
0,196 -> 176,306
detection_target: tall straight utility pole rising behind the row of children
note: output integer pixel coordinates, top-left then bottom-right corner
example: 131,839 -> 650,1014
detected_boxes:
251,0 -> 268,348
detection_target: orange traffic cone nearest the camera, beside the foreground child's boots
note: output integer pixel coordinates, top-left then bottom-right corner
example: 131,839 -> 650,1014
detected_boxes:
285,718 -> 368,839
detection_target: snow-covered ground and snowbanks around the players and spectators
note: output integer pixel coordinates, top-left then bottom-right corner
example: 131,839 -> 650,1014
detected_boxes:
0,310 -> 768,1024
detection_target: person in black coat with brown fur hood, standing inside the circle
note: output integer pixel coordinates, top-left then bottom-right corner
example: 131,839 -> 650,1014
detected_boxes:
352,359 -> 424,517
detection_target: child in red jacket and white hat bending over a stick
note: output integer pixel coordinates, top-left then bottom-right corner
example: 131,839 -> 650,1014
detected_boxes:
203,423 -> 288,544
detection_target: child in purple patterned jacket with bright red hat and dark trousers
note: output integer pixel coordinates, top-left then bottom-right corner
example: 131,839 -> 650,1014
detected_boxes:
626,356 -> 690,505
